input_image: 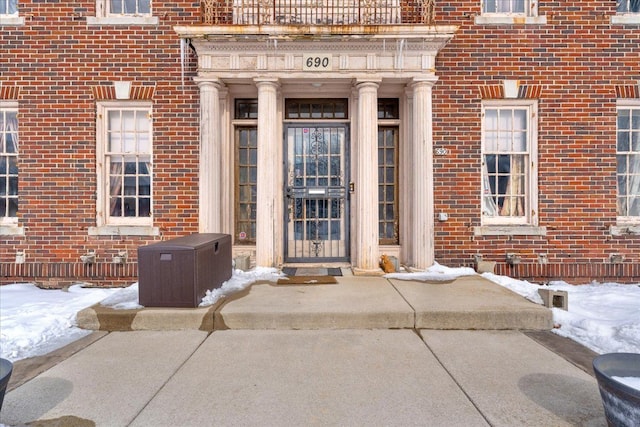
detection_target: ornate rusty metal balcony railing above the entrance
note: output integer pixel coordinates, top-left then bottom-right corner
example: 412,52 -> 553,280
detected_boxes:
201,0 -> 435,25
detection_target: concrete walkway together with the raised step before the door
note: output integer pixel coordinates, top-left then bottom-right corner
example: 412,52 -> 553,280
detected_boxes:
0,276 -> 606,427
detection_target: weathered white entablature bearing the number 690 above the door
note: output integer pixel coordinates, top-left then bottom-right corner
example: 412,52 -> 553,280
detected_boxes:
175,25 -> 457,80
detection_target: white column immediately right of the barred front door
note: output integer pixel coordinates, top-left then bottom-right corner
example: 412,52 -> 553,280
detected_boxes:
354,81 -> 380,273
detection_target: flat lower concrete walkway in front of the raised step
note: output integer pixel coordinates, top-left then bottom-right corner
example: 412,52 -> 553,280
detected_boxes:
0,329 -> 606,427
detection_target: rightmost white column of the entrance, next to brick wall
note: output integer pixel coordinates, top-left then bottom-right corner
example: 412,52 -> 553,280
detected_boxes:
407,80 -> 435,270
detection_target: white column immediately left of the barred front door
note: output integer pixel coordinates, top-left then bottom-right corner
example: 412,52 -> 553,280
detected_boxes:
255,79 -> 283,267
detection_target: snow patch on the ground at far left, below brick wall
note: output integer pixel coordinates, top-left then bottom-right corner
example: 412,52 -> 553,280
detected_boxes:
0,284 -> 117,360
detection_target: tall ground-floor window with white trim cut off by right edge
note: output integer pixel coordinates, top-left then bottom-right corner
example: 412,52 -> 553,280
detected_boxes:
616,101 -> 640,224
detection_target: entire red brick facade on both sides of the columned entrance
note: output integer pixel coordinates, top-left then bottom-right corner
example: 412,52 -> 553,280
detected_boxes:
0,0 -> 640,285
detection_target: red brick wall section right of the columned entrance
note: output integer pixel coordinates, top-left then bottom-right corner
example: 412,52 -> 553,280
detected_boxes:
433,1 -> 640,281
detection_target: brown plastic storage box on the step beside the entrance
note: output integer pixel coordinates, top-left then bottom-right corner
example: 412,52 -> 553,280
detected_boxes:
138,233 -> 232,308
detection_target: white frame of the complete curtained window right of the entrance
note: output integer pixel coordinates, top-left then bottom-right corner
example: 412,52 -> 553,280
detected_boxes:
480,100 -> 538,229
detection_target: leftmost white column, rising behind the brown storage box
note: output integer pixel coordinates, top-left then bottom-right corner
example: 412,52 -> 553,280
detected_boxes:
198,81 -> 223,233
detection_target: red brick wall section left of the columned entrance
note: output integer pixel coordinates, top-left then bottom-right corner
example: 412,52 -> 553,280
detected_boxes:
0,0 -> 200,283
